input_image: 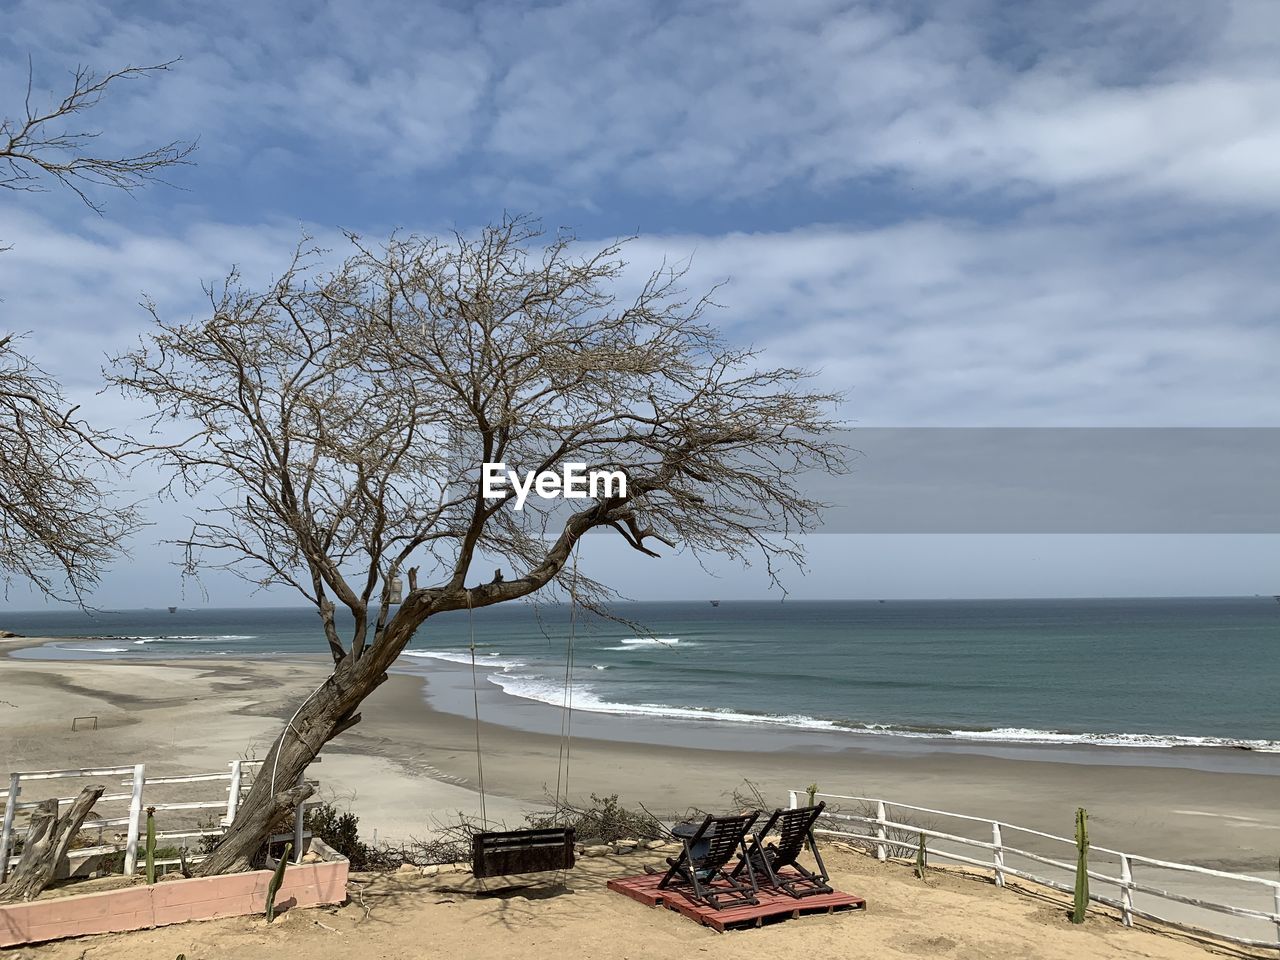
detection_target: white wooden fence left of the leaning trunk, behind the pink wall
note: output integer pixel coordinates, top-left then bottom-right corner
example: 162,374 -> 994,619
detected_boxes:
0,758 -> 319,883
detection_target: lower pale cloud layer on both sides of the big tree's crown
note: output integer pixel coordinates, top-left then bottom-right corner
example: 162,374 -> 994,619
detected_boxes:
0,209 -> 1280,426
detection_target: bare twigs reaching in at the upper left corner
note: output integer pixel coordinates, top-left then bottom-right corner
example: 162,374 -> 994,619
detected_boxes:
0,60 -> 196,212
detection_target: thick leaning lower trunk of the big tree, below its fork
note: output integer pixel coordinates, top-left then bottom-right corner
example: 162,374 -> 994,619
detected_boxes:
195,660 -> 391,877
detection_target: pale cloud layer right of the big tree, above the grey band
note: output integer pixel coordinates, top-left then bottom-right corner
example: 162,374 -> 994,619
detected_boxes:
614,221 -> 1280,426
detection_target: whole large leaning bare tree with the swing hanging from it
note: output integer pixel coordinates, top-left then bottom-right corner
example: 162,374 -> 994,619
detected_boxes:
111,219 -> 844,874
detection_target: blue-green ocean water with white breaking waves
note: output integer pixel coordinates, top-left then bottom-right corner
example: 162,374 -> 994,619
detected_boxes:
0,596 -> 1280,751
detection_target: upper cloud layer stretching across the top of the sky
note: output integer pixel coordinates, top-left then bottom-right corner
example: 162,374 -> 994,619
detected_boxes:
0,0 -> 1280,209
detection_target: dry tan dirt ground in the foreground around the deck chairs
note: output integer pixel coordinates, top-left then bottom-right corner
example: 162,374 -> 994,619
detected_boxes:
4,849 -> 1259,960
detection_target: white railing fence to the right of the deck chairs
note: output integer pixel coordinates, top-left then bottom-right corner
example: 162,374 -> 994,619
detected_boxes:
788,790 -> 1280,948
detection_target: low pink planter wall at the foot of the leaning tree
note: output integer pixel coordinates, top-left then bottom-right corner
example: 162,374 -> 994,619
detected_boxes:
0,840 -> 348,947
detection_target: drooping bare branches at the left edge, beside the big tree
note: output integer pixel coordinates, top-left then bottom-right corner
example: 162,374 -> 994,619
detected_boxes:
0,335 -> 138,599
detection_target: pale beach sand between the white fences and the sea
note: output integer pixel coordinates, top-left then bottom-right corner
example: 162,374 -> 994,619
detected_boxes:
0,647 -> 1280,876
